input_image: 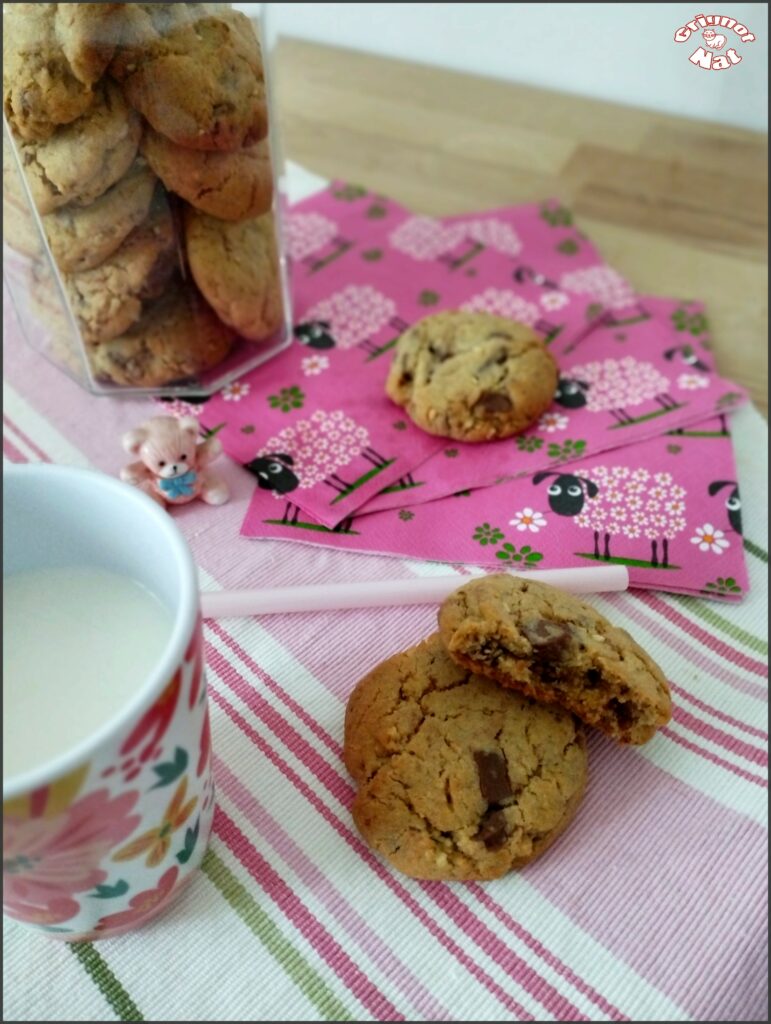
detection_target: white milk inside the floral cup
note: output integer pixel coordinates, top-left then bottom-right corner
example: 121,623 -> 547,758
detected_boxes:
3,567 -> 172,778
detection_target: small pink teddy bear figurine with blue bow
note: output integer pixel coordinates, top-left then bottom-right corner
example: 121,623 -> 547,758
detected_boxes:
121,416 -> 229,508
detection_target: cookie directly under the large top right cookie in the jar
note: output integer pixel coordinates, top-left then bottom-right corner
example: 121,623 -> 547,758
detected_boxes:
142,129 -> 273,220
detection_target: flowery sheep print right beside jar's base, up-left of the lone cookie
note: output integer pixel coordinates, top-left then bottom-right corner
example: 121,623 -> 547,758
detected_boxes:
295,285 -> 409,353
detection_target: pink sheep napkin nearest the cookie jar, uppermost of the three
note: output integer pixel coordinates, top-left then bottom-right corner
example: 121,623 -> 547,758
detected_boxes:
193,185 -> 618,526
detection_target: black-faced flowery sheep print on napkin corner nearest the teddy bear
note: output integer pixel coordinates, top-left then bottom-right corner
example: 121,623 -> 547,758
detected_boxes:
245,409 -> 390,516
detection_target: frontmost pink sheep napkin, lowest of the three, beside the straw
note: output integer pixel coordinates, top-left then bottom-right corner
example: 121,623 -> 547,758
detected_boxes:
242,418 -> 748,600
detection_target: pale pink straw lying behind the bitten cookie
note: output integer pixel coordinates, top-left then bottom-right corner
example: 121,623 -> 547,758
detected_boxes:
201,565 -> 629,618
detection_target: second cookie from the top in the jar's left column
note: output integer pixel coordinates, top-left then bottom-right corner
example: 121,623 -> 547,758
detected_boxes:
16,82 -> 141,214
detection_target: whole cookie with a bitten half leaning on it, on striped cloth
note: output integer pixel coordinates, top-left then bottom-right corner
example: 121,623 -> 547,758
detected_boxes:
344,575 -> 672,881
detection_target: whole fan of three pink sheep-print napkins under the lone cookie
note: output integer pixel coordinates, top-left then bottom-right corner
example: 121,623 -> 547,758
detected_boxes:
191,182 -> 746,599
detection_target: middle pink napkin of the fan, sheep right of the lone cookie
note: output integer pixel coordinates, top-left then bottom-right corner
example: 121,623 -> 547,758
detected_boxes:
359,296 -> 746,514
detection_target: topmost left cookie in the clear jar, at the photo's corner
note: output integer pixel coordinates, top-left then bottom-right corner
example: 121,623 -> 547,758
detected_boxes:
3,3 -> 119,140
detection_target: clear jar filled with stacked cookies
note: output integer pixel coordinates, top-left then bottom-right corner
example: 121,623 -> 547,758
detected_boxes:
3,3 -> 291,396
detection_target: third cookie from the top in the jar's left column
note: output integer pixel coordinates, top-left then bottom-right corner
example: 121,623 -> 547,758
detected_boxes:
43,157 -> 158,273
